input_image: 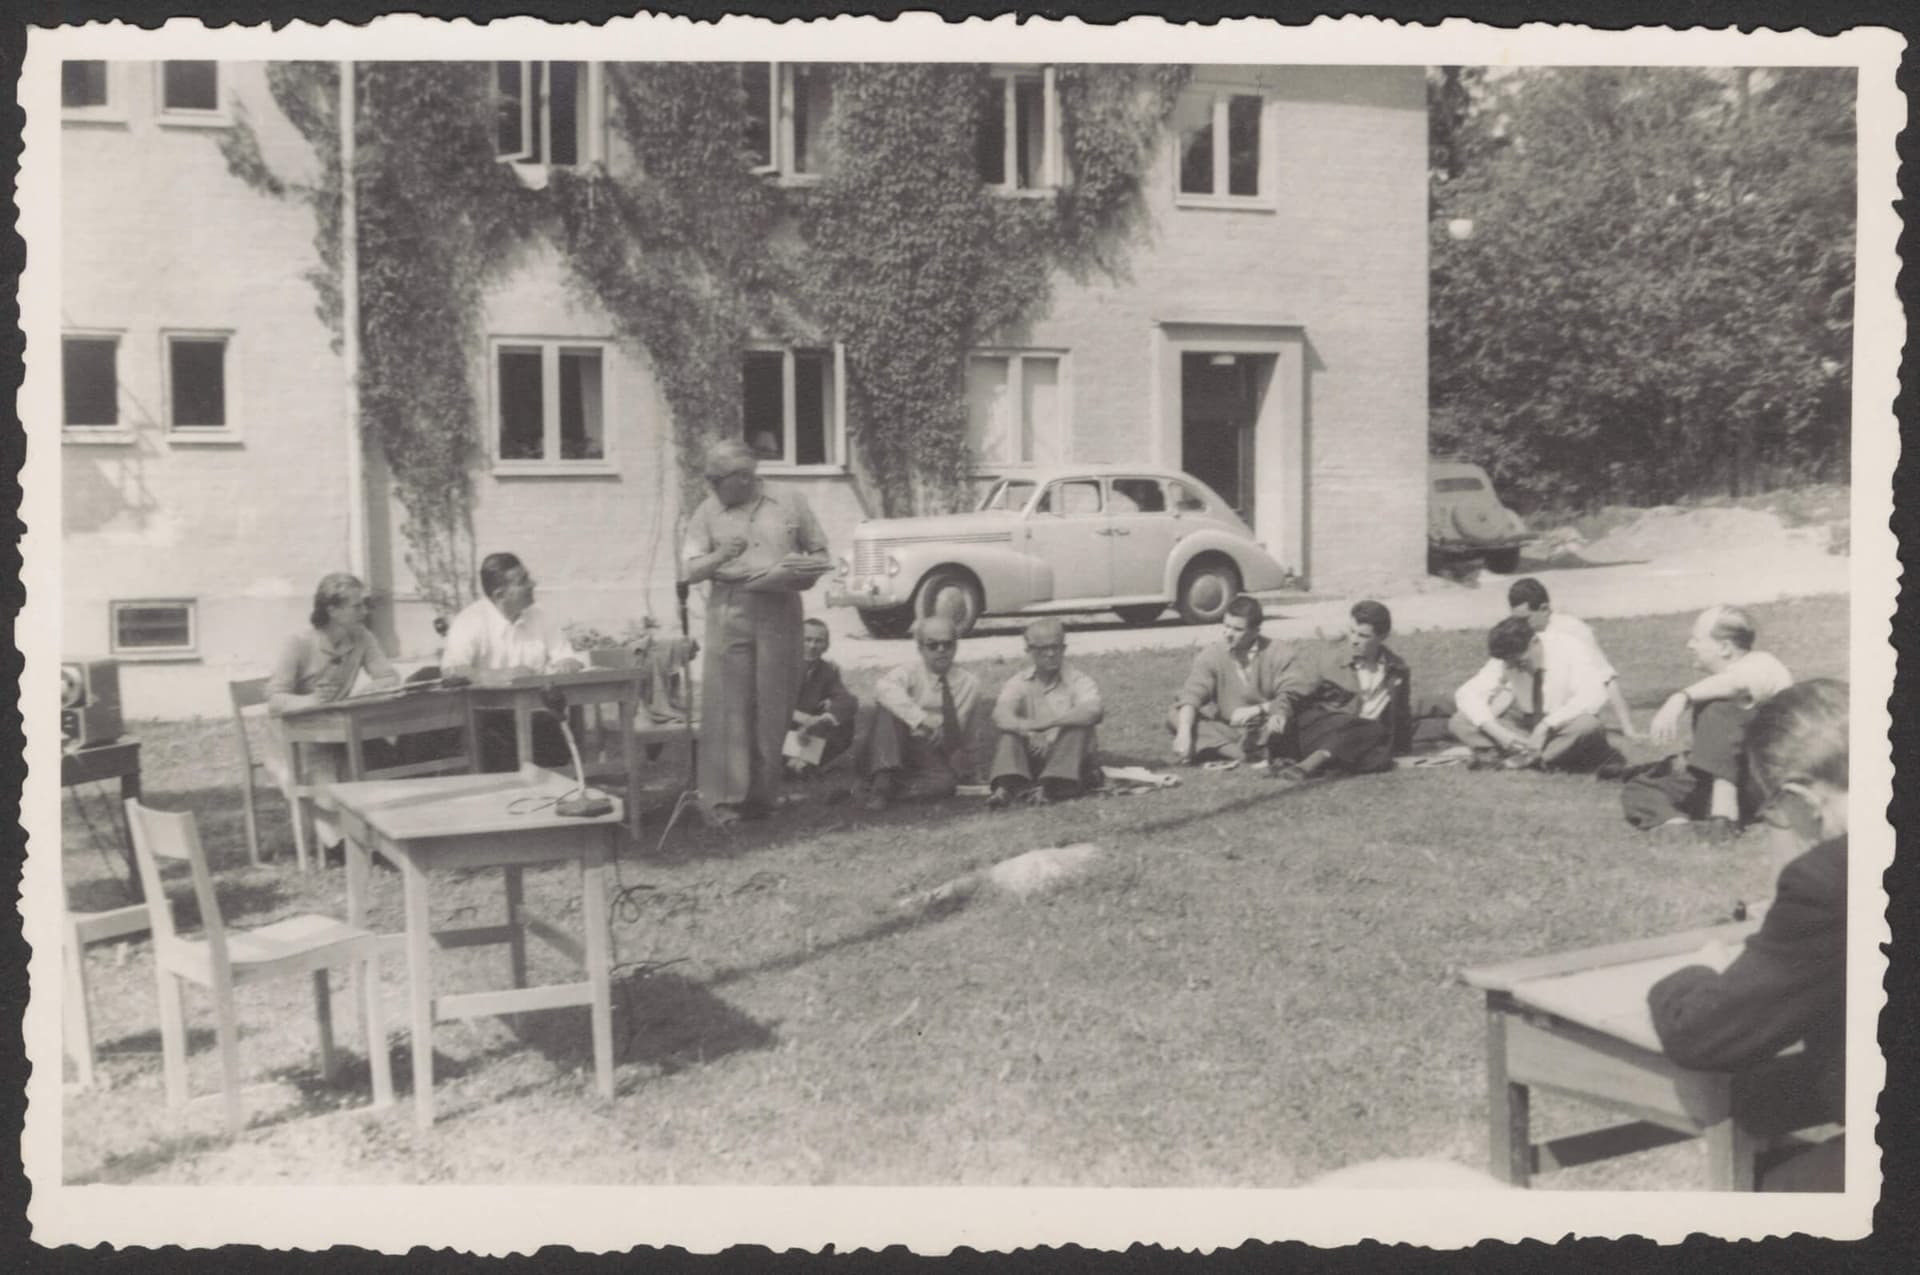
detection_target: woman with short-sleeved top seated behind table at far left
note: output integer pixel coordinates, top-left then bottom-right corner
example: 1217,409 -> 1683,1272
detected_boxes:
267,570 -> 399,847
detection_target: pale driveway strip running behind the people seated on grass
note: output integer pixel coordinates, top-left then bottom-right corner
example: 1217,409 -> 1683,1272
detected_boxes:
808,528 -> 1849,668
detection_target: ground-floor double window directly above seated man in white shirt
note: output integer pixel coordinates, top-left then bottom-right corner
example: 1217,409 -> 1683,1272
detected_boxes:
493,342 -> 607,465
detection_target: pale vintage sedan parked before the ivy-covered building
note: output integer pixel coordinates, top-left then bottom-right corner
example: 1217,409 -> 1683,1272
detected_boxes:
828,465 -> 1292,638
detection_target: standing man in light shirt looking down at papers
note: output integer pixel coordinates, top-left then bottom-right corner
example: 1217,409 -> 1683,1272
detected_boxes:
682,438 -> 828,828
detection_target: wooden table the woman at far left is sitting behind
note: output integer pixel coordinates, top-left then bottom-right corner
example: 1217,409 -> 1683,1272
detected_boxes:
273,687 -> 480,872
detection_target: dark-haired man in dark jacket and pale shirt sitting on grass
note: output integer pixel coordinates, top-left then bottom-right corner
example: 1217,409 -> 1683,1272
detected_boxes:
1271,601 -> 1413,783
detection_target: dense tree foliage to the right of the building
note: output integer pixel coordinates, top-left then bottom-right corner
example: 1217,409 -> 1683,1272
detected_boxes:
1428,67 -> 1855,505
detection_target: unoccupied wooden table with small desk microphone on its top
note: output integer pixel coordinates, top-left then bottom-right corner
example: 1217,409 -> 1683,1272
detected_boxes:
332,768 -> 624,1127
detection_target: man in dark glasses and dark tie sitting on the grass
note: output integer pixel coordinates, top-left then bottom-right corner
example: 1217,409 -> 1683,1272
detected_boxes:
854,616 -> 979,810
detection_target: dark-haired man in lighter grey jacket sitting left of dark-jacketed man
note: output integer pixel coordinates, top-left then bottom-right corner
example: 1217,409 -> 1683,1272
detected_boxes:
1167,593 -> 1311,766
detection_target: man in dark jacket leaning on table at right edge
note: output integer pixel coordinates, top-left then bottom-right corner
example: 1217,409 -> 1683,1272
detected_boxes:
1647,678 -> 1847,1191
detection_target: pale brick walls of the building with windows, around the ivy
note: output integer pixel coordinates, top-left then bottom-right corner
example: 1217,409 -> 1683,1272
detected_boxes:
61,61 -> 1427,716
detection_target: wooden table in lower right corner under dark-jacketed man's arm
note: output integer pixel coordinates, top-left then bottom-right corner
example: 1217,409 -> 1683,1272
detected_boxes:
1459,920 -> 1841,1191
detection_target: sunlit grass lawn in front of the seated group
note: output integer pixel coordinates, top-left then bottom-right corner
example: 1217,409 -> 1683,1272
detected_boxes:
52,597 -> 1847,1189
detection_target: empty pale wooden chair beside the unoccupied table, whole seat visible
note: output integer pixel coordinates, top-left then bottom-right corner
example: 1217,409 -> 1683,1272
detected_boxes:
127,801 -> 394,1133
